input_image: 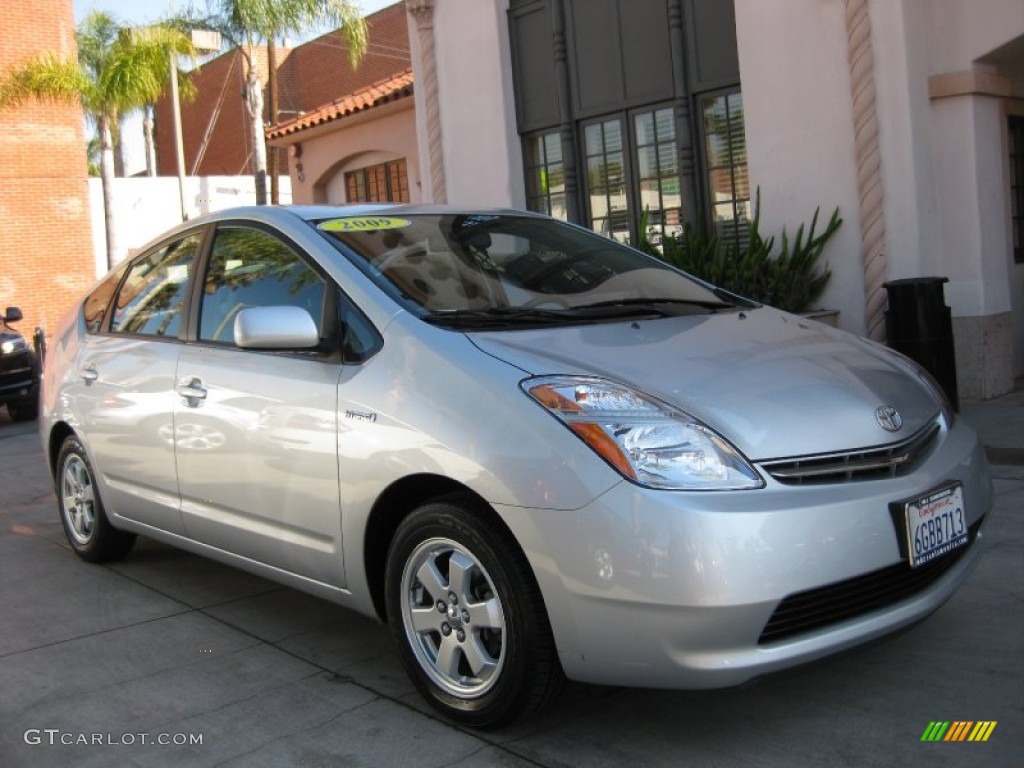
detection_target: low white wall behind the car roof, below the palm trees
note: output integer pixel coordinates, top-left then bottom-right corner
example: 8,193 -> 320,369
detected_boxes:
89,176 -> 292,276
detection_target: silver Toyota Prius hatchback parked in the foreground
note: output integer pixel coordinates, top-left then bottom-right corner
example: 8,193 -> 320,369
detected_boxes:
40,206 -> 992,727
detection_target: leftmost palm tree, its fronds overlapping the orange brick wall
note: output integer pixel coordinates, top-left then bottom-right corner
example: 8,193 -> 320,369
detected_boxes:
0,11 -> 195,266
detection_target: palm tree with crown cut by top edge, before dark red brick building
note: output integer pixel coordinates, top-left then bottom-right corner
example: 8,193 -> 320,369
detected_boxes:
177,0 -> 367,205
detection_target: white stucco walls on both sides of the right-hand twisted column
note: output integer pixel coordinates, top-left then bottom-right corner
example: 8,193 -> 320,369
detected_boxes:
735,0 -> 1024,396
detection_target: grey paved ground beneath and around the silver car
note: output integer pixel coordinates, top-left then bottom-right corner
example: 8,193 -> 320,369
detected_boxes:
0,421 -> 1024,768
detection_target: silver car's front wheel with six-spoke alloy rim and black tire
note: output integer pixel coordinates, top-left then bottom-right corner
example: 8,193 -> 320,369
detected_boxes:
386,498 -> 563,727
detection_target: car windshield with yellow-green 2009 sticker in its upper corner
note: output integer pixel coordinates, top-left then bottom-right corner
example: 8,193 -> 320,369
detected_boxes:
314,214 -> 738,326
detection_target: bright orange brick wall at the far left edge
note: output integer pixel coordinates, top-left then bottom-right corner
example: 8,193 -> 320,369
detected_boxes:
0,0 -> 95,337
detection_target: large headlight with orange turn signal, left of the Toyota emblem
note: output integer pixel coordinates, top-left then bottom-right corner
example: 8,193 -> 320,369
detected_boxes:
521,376 -> 764,490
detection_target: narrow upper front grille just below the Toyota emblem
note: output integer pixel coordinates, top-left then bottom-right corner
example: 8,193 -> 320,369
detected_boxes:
761,422 -> 939,485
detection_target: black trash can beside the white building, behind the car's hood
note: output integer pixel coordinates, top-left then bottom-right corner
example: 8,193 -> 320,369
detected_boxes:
885,278 -> 959,411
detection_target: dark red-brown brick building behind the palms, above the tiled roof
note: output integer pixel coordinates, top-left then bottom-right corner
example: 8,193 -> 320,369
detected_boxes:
156,2 -> 412,176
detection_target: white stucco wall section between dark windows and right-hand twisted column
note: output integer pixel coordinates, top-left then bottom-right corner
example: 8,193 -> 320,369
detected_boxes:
735,0 -> 866,333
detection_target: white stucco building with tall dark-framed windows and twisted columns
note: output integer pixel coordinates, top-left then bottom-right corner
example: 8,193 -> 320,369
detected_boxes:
370,0 -> 1024,397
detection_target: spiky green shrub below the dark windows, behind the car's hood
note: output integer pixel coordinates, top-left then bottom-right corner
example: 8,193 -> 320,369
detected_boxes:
637,191 -> 843,312
